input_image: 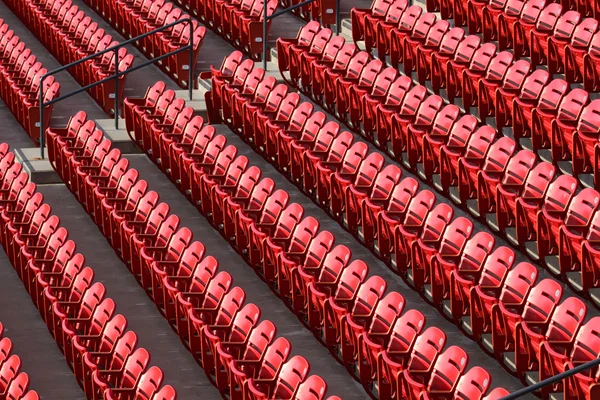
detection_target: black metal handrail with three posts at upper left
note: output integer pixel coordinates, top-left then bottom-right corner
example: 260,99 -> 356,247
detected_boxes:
39,17 -> 196,159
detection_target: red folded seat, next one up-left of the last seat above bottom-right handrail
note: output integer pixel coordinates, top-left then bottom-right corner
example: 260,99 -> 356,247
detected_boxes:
515,297 -> 587,379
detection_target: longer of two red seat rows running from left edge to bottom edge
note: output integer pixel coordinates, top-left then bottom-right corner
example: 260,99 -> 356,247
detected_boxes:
0,142 -> 176,400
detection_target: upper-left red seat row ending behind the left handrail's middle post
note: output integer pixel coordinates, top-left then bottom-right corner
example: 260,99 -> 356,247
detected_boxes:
6,0 -> 133,113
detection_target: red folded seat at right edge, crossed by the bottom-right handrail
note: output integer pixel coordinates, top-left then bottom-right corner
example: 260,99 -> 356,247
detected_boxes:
539,317 -> 600,398
